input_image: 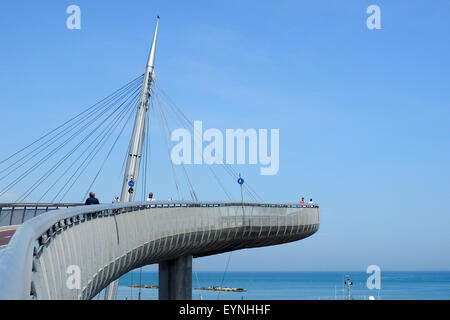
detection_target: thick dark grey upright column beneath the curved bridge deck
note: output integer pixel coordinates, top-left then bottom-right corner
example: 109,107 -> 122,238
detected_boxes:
159,256 -> 192,300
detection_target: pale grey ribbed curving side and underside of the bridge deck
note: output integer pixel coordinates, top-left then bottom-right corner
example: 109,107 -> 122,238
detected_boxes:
0,202 -> 320,299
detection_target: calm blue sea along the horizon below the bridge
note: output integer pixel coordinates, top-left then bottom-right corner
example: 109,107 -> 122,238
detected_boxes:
109,271 -> 450,300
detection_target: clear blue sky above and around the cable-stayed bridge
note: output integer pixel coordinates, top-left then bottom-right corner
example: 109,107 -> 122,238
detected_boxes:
0,0 -> 450,270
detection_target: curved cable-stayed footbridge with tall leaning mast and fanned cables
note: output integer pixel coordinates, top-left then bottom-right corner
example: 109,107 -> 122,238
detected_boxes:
0,18 -> 319,299
